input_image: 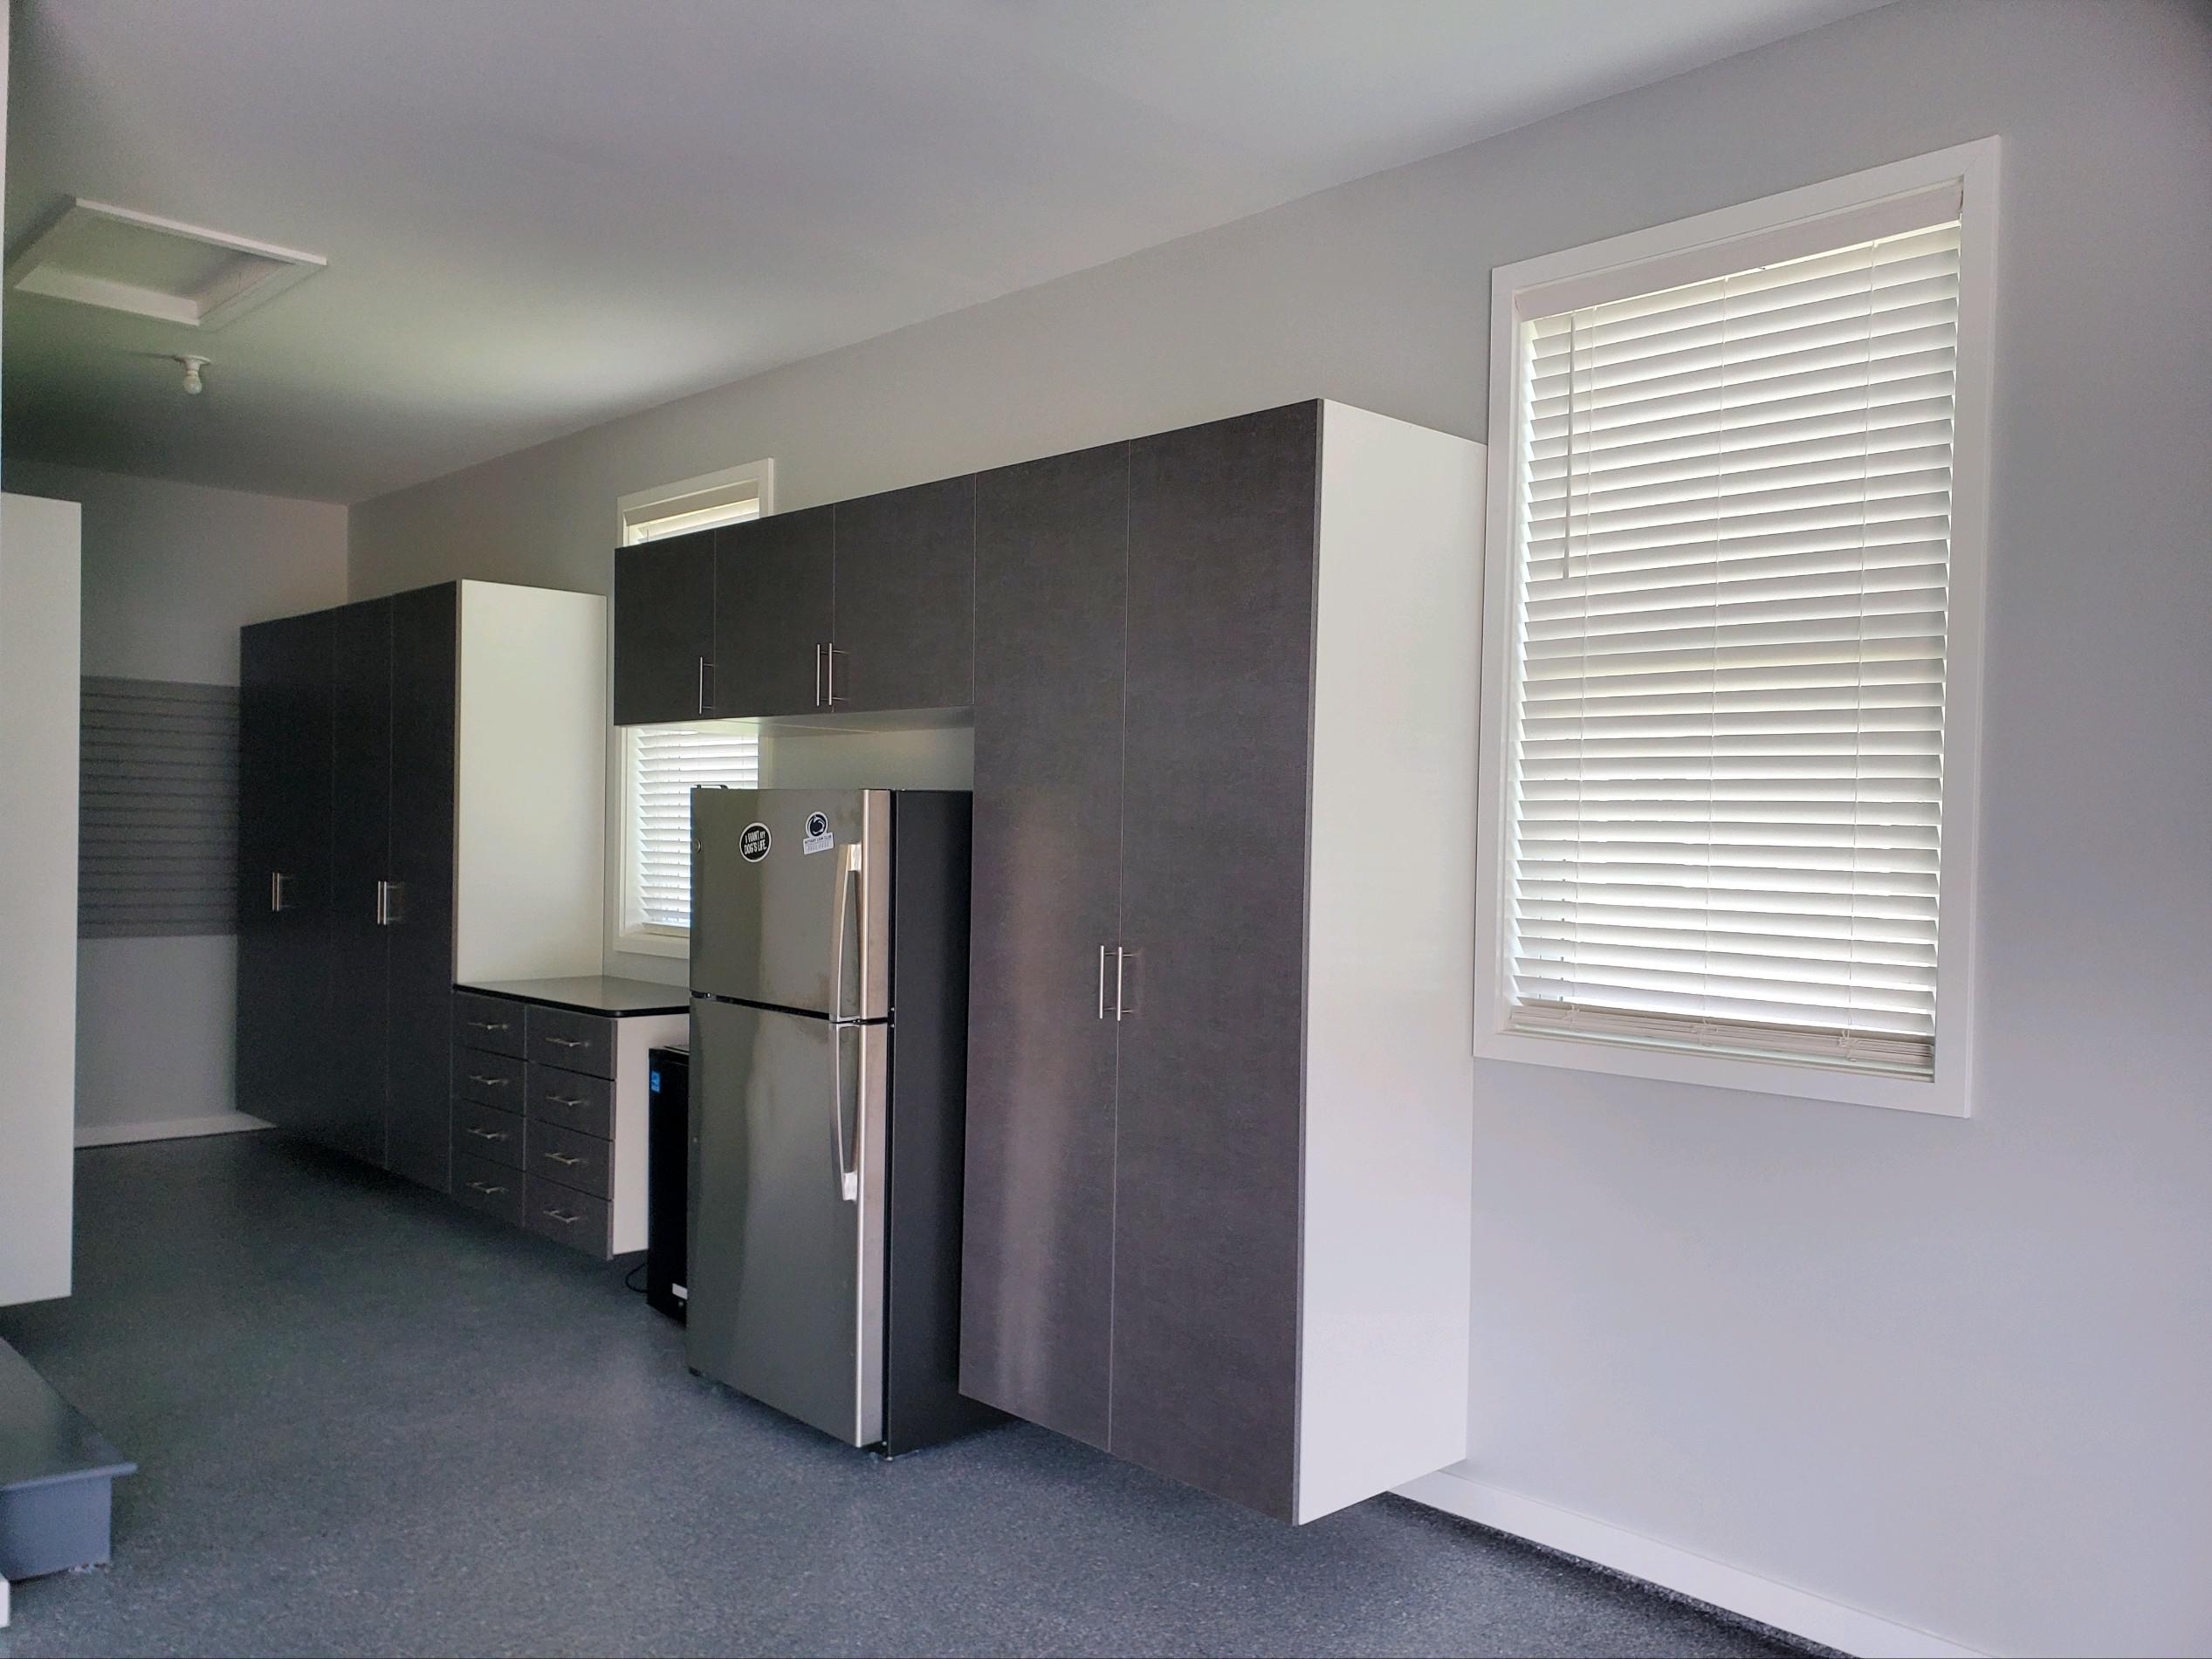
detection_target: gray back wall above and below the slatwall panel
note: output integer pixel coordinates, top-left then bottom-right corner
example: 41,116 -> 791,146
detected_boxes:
7,460 -> 345,1139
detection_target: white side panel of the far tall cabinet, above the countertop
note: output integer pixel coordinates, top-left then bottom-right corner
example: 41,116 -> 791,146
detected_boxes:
453,582 -> 606,980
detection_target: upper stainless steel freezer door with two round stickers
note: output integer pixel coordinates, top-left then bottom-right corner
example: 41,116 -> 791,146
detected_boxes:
690,790 -> 891,1019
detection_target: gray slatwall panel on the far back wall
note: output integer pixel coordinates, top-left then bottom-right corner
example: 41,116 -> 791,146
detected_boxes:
78,675 -> 239,938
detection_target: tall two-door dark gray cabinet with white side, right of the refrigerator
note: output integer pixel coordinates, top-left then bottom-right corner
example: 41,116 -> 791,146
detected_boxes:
960,402 -> 1482,1522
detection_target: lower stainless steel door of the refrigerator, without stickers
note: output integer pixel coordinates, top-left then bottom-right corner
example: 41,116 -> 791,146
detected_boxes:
684,1000 -> 891,1447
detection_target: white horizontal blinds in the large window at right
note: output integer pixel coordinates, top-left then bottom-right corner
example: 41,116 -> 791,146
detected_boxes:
1508,217 -> 1958,1075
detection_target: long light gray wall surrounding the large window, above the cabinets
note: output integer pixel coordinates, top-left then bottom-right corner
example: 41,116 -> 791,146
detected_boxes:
352,0 -> 2212,1652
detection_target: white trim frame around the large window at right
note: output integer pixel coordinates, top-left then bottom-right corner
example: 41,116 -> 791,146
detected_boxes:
1475,137 -> 1997,1117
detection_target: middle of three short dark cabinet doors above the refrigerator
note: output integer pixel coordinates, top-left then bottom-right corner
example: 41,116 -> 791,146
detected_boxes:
714,506 -> 834,716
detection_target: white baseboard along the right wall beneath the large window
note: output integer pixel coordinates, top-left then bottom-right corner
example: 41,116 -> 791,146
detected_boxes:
1398,1469 -> 1984,1659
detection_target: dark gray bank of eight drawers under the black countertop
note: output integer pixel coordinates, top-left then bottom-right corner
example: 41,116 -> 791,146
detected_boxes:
453,991 -> 615,1261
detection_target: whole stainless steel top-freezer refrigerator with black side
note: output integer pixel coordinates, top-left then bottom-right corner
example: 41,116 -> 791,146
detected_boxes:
684,790 -> 995,1453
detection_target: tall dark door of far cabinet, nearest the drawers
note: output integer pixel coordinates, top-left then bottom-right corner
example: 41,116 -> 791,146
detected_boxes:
385,584 -> 460,1192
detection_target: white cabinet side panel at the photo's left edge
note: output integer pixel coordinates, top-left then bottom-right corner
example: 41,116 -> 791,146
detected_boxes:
0,496 -> 82,1305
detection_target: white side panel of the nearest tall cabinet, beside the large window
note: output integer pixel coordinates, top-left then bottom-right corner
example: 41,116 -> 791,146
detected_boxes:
1296,402 -> 1484,1522
